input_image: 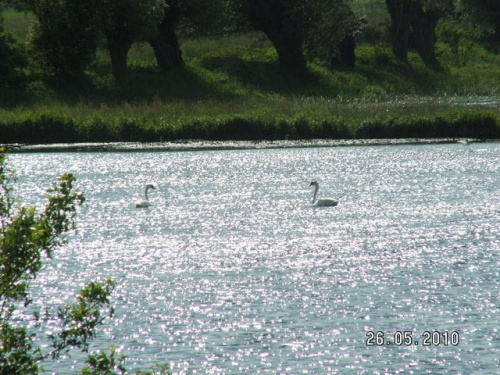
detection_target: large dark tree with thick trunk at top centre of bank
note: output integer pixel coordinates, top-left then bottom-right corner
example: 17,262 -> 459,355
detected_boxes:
230,0 -> 361,76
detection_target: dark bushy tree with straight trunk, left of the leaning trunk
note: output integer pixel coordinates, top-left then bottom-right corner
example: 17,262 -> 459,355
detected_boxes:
25,0 -> 166,84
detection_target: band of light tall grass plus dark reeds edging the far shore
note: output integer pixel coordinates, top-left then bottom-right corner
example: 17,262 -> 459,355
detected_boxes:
0,97 -> 500,144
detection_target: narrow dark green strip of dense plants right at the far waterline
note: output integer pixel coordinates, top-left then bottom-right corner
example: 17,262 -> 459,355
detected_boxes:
0,109 -> 500,144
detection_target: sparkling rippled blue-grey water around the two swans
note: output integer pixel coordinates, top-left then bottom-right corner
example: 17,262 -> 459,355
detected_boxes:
10,143 -> 500,374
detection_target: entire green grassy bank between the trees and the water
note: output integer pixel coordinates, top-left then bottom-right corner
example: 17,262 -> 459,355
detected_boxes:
0,6 -> 500,149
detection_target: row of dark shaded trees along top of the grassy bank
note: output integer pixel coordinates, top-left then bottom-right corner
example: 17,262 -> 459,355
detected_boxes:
0,0 -> 500,86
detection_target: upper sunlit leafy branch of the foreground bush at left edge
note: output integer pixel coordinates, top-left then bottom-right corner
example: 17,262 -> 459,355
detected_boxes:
0,171 -> 85,301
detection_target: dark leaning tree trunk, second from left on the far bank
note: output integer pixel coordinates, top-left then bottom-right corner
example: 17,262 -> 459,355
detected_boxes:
149,2 -> 184,73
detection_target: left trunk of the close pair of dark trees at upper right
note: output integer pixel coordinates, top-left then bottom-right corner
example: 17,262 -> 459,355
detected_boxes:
385,0 -> 414,62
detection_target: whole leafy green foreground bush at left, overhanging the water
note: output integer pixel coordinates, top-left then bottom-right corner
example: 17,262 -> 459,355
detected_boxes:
0,149 -> 168,375
